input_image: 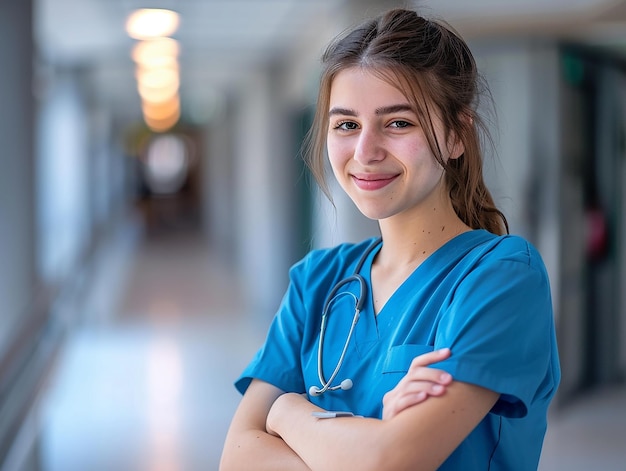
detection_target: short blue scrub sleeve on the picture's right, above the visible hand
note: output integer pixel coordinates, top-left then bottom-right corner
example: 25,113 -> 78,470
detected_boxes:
435,247 -> 558,417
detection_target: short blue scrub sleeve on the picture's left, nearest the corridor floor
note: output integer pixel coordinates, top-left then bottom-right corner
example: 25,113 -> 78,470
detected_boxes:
235,263 -> 305,394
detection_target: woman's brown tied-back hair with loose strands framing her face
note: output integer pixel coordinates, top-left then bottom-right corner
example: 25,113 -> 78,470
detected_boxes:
305,9 -> 508,234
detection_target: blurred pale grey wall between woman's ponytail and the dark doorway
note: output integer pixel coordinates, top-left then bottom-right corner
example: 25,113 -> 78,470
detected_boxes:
471,39 -> 561,306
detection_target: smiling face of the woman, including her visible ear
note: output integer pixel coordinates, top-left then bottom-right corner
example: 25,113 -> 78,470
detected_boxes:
327,68 -> 462,220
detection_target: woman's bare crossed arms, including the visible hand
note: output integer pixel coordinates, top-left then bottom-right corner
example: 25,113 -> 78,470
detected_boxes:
220,350 -> 498,471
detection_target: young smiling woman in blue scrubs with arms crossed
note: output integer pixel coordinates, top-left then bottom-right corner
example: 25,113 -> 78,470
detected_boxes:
221,9 -> 560,471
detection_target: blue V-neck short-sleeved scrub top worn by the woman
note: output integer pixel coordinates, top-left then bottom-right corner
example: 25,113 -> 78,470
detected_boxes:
235,230 -> 560,471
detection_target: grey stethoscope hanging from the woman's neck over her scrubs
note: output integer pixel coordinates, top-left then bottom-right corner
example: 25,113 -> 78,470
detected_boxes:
309,237 -> 382,396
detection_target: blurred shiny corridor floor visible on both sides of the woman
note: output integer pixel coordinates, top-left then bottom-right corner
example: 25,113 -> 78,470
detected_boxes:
38,225 -> 626,471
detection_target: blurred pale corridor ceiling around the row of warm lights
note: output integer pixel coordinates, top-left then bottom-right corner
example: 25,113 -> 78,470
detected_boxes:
34,0 -> 626,127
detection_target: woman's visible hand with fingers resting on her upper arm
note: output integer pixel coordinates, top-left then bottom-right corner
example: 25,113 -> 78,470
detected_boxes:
383,348 -> 452,420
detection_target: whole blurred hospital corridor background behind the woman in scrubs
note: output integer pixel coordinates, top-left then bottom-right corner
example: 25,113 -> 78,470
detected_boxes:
0,0 -> 626,471
